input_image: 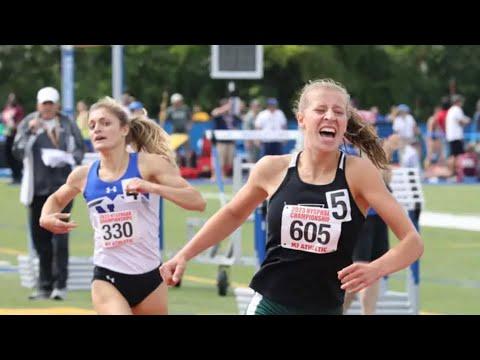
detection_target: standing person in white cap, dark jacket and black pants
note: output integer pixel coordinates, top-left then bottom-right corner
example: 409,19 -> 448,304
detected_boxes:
13,87 -> 84,300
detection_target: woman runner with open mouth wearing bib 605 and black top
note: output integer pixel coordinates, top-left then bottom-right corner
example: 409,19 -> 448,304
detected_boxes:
160,79 -> 423,315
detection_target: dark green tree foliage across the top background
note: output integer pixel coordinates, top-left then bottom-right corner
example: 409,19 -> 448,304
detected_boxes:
0,45 -> 480,121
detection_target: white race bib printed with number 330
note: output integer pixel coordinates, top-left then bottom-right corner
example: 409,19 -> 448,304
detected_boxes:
96,210 -> 137,248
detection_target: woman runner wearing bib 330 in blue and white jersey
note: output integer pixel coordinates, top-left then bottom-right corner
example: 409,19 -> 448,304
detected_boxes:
40,97 -> 206,314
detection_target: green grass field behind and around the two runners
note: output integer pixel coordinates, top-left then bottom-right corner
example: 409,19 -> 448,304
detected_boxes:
0,182 -> 480,314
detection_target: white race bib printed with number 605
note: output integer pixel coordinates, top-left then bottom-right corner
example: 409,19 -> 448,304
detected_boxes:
281,205 -> 342,254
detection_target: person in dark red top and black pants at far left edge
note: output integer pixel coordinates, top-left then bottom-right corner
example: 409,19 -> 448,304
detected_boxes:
2,93 -> 24,185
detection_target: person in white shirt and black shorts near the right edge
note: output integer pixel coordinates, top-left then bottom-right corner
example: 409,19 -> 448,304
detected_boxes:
445,95 -> 470,176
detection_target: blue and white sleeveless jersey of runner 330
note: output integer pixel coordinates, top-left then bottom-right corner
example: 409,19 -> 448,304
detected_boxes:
83,153 -> 161,274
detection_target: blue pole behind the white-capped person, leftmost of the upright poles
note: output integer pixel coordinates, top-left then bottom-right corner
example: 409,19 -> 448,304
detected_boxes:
61,45 -> 75,119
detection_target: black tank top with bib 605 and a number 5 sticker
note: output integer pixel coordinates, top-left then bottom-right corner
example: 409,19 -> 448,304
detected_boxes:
250,152 -> 365,311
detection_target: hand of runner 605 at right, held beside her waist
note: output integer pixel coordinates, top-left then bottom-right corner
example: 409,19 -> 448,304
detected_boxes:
338,262 -> 381,292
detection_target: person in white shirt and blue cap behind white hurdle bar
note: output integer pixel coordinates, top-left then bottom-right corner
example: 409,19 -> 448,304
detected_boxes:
255,98 -> 287,156
